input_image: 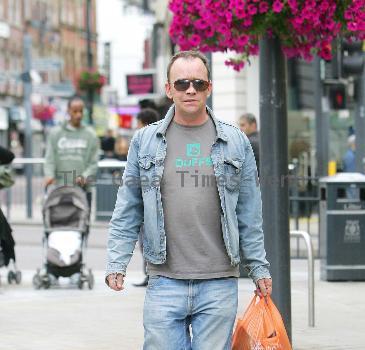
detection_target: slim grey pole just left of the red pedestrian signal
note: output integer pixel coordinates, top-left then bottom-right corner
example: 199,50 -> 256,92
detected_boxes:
313,57 -> 329,177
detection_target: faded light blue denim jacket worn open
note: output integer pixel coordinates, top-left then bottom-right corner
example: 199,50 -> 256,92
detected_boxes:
106,106 -> 270,282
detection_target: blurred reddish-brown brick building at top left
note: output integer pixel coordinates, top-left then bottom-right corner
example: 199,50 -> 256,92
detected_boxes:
0,0 -> 97,106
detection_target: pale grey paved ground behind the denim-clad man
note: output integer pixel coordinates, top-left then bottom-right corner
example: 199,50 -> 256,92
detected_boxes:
0,255 -> 365,350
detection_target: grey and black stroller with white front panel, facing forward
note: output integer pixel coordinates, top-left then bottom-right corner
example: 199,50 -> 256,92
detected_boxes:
33,186 -> 94,289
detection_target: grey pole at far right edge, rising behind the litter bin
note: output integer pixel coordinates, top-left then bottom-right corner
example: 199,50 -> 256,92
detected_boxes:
355,61 -> 365,173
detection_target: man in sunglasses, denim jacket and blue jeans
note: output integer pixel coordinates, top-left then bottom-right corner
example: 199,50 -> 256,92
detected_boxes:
106,51 -> 272,350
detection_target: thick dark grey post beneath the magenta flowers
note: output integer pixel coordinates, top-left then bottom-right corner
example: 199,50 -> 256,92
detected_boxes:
260,38 -> 291,339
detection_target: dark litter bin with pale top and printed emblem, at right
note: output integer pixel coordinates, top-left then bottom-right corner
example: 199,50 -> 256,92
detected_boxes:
319,173 -> 365,281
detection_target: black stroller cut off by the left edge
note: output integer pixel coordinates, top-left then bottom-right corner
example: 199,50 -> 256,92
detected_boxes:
0,209 -> 22,284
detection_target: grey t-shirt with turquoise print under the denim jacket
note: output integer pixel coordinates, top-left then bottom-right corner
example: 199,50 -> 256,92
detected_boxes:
148,118 -> 239,279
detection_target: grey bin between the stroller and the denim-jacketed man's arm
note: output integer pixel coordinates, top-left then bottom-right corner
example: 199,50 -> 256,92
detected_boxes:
95,159 -> 126,221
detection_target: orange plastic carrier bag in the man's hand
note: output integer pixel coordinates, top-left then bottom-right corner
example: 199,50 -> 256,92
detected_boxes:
232,295 -> 292,350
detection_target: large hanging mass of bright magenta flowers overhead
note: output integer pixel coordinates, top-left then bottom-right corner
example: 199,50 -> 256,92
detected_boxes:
169,0 -> 365,70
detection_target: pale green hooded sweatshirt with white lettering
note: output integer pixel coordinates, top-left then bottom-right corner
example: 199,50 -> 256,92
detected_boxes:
44,122 -> 99,190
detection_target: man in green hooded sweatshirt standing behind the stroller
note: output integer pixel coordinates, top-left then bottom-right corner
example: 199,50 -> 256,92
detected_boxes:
44,96 -> 99,207
